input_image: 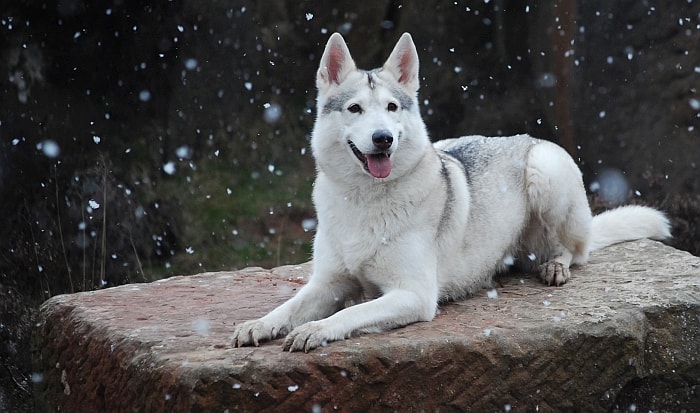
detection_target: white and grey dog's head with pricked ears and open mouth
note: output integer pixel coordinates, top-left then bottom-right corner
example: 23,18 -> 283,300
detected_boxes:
311,33 -> 429,180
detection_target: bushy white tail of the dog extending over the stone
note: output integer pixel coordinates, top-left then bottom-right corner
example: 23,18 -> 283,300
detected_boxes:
590,205 -> 671,250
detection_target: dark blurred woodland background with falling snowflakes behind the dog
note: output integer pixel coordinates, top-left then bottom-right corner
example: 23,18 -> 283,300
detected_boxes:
0,0 -> 700,412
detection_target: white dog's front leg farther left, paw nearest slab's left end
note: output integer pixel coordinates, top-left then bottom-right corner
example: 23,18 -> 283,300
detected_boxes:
232,277 -> 356,347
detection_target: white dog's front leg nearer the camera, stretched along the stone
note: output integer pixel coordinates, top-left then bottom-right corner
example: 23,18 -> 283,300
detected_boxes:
284,289 -> 437,352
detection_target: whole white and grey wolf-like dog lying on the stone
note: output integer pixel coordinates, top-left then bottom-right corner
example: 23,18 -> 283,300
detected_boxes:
233,33 -> 671,351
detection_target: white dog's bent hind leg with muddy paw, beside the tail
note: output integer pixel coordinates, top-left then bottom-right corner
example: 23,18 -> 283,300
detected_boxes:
525,142 -> 592,285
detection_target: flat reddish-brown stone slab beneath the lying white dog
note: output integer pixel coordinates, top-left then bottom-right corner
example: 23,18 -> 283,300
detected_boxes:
35,240 -> 700,412
